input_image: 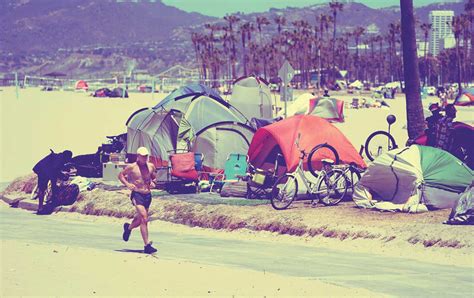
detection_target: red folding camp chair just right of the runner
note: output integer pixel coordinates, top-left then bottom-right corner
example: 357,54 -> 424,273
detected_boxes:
165,152 -> 202,193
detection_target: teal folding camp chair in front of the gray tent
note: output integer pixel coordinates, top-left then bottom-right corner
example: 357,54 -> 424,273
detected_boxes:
209,153 -> 247,192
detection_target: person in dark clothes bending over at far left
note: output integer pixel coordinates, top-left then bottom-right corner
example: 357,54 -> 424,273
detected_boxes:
33,150 -> 72,214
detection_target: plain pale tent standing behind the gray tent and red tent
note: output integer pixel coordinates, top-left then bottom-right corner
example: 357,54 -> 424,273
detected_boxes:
230,77 -> 273,119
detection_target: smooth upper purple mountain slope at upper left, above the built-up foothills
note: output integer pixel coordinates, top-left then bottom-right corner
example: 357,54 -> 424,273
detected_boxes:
0,0 -> 214,52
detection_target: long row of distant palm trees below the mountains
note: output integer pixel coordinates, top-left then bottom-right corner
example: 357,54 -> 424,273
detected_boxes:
191,1 -> 473,86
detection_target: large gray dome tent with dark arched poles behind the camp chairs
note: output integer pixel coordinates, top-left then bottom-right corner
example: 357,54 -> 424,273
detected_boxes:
127,94 -> 253,169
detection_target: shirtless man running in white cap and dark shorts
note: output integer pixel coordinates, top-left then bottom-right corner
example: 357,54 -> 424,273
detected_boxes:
118,147 -> 157,254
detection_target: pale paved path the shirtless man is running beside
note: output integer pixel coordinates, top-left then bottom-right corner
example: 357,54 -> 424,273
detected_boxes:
0,208 -> 474,297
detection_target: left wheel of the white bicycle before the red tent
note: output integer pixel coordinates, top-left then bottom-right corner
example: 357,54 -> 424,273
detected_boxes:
271,174 -> 298,210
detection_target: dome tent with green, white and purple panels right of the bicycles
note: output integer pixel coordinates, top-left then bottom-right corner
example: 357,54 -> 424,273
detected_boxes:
353,145 -> 474,211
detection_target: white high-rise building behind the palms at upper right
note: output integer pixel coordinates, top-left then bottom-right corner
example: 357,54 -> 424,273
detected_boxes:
429,10 -> 454,55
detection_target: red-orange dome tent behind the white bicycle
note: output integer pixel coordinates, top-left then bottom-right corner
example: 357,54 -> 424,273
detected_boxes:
248,115 -> 366,172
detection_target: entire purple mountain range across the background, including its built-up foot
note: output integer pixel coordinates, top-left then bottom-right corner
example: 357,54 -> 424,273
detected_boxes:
0,0 -> 464,76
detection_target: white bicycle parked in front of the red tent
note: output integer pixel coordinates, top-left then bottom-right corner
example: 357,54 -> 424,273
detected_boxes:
271,135 -> 347,210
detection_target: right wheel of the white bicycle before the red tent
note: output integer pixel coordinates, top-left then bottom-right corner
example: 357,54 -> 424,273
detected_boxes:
317,169 -> 347,206
